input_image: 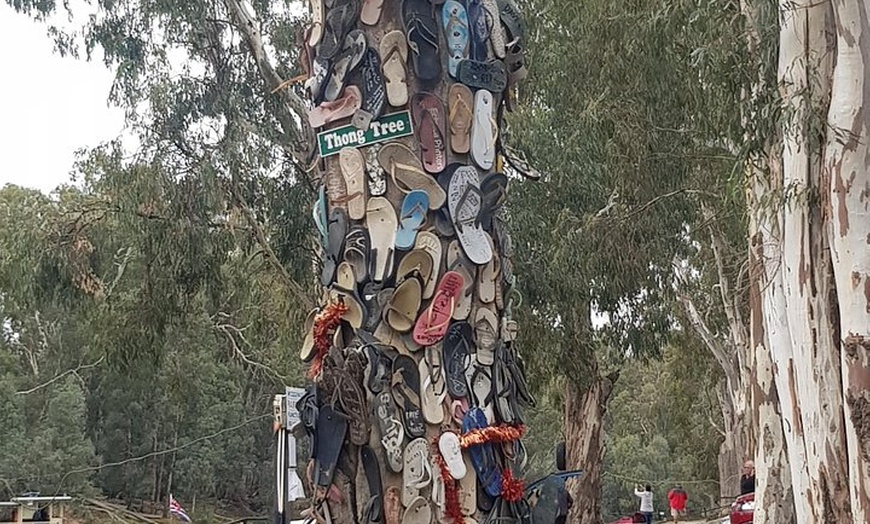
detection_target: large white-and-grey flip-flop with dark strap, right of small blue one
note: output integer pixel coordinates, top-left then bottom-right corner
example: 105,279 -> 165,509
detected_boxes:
448,166 -> 492,265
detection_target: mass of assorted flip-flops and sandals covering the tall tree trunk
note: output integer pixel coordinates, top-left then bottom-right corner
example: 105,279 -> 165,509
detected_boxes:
298,0 -> 534,524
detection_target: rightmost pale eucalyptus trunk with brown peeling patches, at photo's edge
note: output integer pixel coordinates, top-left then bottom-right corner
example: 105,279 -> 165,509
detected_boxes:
825,0 -> 870,522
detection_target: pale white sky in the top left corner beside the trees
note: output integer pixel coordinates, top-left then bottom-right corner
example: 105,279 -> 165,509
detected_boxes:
0,2 -> 124,193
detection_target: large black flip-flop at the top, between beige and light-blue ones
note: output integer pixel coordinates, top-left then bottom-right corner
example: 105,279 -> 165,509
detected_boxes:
402,0 -> 441,83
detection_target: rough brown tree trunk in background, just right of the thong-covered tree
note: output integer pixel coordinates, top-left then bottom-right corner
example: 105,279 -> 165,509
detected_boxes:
565,373 -> 619,524
